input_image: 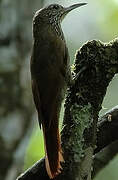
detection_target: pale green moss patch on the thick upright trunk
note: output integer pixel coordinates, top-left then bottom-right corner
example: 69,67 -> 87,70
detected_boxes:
68,104 -> 92,161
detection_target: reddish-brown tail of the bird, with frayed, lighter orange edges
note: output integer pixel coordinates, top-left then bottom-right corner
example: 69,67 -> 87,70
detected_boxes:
42,124 -> 64,179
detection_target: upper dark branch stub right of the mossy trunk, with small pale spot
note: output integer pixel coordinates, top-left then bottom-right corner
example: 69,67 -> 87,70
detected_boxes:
95,106 -> 118,154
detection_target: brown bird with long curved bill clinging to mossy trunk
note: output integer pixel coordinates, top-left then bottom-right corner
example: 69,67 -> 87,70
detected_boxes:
30,3 -> 86,179
